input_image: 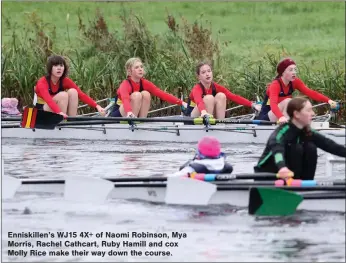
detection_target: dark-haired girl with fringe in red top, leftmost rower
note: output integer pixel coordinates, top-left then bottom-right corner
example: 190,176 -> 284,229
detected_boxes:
33,55 -> 105,118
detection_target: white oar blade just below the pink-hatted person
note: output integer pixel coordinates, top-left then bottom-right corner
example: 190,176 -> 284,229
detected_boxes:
165,176 -> 217,206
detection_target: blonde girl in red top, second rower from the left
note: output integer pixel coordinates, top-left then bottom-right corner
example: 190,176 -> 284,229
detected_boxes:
110,58 -> 187,118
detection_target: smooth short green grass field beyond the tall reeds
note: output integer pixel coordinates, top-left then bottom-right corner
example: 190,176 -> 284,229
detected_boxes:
2,2 -> 345,71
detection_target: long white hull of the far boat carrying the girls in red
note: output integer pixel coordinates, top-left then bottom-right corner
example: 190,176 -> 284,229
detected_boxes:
2,122 -> 345,144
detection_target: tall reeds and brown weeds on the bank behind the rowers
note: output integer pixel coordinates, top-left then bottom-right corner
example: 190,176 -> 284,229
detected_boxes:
1,10 -> 345,120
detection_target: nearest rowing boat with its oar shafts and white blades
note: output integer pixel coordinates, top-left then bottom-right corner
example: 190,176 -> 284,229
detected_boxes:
3,176 -> 345,212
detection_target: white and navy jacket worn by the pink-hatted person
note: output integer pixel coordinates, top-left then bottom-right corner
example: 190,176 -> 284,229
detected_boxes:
179,153 -> 233,174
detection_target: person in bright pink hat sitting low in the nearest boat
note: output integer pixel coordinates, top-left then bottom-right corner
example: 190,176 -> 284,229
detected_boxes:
174,136 -> 233,176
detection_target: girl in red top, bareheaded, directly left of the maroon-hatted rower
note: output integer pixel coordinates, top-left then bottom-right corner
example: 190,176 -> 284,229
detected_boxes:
185,62 -> 261,119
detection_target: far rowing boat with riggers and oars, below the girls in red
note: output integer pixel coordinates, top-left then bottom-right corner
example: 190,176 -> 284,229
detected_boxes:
2,111 -> 345,144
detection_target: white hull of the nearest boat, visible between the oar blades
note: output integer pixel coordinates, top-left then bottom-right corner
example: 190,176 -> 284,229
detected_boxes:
12,184 -> 345,213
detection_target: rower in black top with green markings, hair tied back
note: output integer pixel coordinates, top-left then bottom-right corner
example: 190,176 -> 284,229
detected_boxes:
254,98 -> 346,180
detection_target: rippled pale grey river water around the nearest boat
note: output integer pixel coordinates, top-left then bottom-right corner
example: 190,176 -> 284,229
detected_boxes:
2,139 -> 345,262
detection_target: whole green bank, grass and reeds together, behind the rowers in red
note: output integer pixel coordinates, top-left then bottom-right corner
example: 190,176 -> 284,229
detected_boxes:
2,2 -> 345,118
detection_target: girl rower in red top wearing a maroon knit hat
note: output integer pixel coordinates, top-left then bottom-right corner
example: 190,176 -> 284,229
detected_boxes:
257,58 -> 338,124
